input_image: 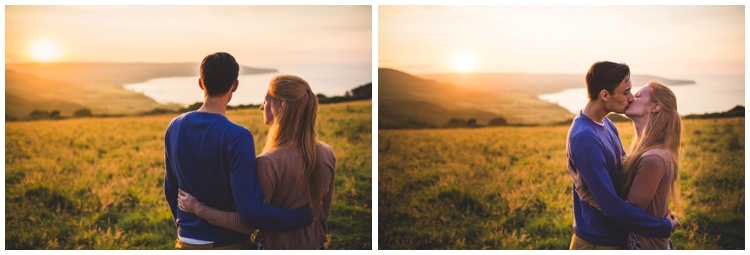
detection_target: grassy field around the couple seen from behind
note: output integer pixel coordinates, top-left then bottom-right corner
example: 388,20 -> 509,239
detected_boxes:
5,101 -> 372,249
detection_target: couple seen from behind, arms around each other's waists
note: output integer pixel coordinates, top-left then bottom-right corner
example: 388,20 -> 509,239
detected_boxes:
164,52 -> 336,250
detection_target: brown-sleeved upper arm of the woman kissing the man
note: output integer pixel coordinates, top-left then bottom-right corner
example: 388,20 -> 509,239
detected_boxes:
626,154 -> 667,210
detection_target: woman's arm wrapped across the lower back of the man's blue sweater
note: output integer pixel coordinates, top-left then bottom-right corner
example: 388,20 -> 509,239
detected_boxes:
177,190 -> 255,234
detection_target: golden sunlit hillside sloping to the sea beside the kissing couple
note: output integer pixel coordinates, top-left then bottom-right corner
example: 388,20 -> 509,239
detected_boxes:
378,68 -> 573,128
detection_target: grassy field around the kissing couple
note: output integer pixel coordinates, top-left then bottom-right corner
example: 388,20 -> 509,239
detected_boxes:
378,118 -> 745,249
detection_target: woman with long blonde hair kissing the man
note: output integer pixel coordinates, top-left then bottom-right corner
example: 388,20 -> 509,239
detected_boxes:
576,81 -> 682,250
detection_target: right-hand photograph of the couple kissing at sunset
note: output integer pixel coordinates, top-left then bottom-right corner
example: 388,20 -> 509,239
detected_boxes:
376,5 -> 745,250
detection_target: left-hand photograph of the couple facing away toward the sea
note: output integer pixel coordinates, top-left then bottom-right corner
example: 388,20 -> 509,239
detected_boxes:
5,6 -> 373,250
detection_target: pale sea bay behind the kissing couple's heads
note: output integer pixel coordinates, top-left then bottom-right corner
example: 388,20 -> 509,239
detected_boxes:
539,74 -> 745,115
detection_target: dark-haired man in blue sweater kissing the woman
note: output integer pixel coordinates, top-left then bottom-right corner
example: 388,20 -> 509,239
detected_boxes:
566,61 -> 679,250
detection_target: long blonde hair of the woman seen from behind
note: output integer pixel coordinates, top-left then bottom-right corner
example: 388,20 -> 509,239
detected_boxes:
263,75 -> 323,219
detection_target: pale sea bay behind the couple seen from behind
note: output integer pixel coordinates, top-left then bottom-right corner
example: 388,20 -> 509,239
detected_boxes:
124,63 -> 372,106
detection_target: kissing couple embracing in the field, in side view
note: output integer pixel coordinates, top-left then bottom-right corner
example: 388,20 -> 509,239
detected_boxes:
566,61 -> 682,250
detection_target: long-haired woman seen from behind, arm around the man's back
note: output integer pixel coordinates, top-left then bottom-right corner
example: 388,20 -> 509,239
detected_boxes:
178,75 -> 336,249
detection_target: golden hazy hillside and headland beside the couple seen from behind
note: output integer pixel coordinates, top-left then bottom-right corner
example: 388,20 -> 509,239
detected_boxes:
5,63 -> 276,119
